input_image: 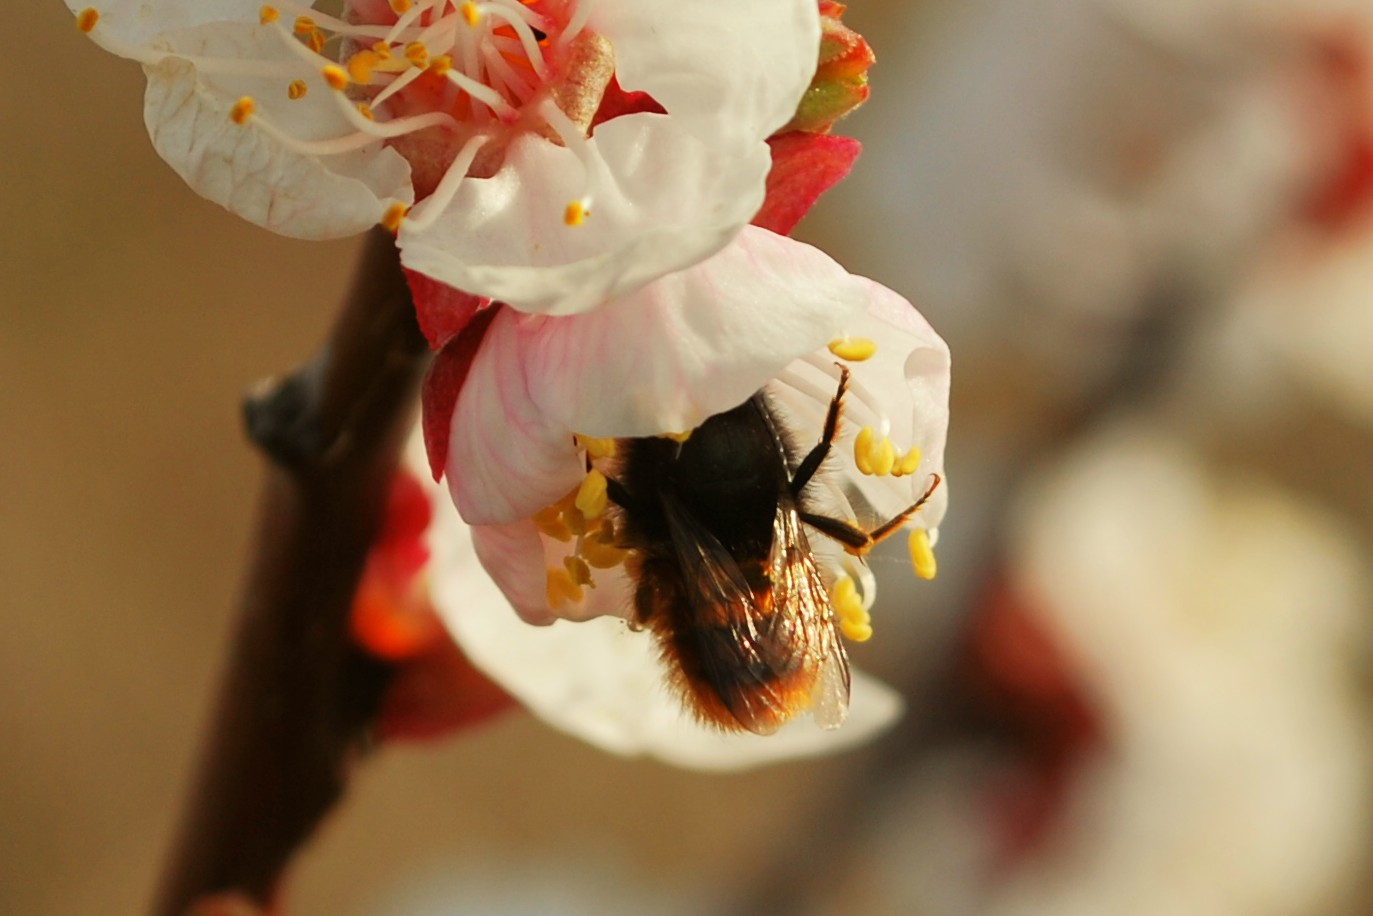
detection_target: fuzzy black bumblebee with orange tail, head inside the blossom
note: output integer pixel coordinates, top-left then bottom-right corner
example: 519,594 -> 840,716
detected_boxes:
607,367 -> 939,735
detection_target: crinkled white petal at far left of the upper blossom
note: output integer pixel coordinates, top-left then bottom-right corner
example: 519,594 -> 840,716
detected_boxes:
144,22 -> 413,239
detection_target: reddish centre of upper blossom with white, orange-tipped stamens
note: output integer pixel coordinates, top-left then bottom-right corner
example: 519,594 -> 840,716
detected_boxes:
77,0 -> 614,229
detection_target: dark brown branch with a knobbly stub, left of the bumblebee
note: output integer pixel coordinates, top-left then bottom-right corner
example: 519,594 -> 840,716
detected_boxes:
154,231 -> 428,916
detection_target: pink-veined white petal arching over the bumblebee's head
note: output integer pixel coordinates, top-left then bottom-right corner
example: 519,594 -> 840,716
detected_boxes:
448,227 -> 868,525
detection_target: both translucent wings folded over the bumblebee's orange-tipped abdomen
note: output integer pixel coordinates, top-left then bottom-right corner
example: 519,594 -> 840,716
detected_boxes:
665,497 -> 849,735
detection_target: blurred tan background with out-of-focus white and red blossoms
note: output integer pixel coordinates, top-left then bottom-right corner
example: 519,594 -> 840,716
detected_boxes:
8,0 -> 1373,916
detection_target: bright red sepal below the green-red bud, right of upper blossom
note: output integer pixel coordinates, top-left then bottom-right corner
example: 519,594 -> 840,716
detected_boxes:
752,130 -> 862,235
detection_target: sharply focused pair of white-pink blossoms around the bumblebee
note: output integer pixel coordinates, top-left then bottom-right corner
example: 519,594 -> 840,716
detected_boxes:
67,0 -> 949,762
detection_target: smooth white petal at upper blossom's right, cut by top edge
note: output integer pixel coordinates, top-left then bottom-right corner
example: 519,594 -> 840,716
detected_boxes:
589,0 -> 820,148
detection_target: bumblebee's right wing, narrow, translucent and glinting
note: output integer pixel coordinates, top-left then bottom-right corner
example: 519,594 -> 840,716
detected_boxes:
770,500 -> 850,728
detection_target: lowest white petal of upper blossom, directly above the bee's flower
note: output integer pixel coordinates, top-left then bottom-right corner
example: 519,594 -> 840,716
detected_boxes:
400,114 -> 772,314
